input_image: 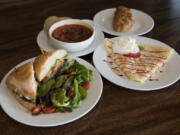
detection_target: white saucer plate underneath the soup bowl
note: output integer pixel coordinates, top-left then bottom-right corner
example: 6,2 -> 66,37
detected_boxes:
37,20 -> 104,57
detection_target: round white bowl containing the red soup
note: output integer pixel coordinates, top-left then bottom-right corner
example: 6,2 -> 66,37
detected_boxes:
49,19 -> 95,52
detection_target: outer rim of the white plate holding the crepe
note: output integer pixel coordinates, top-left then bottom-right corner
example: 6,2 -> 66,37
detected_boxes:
93,36 -> 180,92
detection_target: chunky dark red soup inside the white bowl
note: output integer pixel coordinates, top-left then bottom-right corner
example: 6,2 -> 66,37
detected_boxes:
52,24 -> 93,43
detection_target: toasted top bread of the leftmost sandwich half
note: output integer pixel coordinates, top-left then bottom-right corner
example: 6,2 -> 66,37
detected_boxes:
6,62 -> 36,99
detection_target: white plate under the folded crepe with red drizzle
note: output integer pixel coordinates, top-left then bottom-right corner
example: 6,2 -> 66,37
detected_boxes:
93,36 -> 180,91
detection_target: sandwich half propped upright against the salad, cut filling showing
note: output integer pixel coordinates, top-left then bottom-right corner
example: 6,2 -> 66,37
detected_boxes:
34,49 -> 68,82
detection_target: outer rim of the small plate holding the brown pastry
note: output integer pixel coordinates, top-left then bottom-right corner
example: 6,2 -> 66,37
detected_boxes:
93,7 -> 155,36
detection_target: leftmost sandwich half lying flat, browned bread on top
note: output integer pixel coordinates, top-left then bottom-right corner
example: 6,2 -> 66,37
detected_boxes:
6,62 -> 38,110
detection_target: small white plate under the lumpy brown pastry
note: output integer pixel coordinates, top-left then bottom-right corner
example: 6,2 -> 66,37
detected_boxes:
94,8 -> 154,36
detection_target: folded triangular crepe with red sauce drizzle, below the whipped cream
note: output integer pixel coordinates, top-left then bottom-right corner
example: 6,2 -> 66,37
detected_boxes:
104,39 -> 172,82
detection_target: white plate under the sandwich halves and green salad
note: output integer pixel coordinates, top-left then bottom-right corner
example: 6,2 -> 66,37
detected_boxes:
0,58 -> 103,127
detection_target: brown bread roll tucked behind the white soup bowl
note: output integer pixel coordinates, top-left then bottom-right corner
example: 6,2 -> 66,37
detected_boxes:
43,16 -> 71,37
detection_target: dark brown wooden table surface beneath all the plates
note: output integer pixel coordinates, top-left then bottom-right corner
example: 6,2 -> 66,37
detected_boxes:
0,0 -> 180,135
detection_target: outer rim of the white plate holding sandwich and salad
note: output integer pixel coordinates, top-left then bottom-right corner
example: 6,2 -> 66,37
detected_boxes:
0,57 -> 103,127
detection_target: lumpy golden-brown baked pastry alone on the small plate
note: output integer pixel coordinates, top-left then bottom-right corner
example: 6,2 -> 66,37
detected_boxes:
113,6 -> 135,32
